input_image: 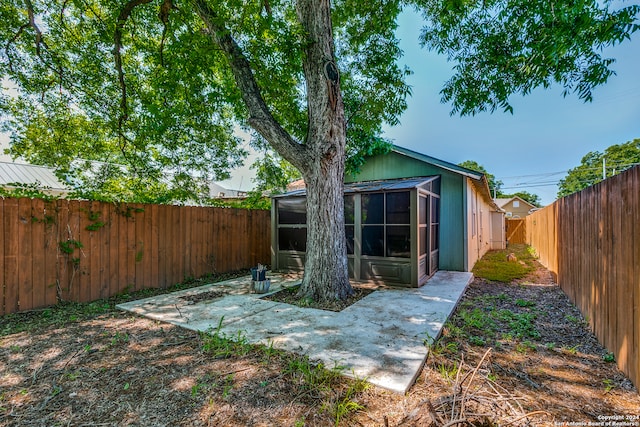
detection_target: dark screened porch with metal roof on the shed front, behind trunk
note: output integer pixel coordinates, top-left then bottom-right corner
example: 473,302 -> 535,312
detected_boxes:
271,176 -> 440,287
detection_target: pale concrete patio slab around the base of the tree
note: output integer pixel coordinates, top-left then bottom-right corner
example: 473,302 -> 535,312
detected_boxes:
118,271 -> 473,393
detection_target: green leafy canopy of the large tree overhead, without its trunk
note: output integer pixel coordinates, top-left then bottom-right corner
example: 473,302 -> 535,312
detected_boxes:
0,0 -> 638,201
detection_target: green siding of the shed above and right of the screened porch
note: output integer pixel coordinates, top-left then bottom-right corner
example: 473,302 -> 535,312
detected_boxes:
345,152 -> 466,271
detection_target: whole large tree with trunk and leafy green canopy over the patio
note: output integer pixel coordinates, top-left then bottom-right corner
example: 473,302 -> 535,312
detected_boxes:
0,0 -> 638,299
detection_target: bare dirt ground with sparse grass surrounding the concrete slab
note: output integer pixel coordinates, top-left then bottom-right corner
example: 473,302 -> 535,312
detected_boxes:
0,262 -> 640,426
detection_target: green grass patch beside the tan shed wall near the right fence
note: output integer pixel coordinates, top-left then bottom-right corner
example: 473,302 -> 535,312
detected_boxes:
472,245 -> 536,283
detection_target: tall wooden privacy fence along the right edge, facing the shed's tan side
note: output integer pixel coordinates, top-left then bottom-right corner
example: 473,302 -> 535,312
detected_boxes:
526,166 -> 640,386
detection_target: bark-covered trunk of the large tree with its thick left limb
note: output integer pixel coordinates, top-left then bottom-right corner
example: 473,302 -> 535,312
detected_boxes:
193,0 -> 353,301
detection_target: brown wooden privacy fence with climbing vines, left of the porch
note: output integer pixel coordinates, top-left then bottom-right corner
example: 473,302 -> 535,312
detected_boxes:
0,198 -> 271,314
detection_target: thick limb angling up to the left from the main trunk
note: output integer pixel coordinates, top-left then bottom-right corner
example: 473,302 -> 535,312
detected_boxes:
193,0 -> 309,169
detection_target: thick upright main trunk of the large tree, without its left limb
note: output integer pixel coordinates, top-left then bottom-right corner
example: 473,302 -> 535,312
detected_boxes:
295,0 -> 353,301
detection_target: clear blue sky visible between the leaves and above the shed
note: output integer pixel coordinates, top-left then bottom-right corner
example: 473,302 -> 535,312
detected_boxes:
0,5 -> 640,205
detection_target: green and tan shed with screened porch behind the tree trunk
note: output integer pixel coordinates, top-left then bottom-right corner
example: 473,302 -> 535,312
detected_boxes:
271,146 -> 504,287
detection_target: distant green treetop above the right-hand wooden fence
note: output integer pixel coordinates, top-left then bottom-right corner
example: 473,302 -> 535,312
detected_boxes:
558,139 -> 640,197
